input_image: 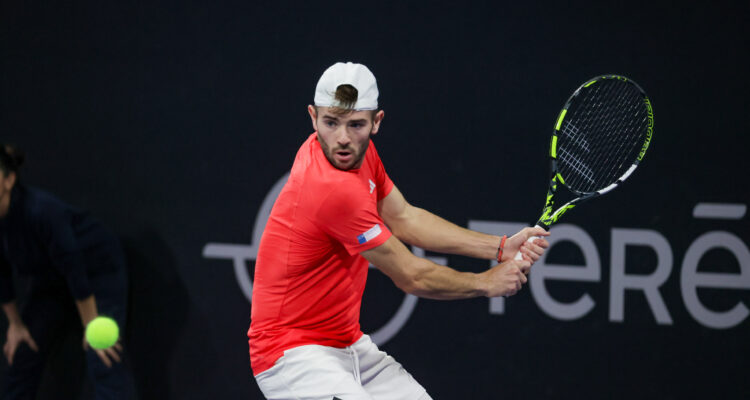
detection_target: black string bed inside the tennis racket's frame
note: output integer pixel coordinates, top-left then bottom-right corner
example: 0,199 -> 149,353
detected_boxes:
557,79 -> 648,192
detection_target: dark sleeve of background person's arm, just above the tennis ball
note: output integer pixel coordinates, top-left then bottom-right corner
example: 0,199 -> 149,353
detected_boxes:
37,204 -> 93,300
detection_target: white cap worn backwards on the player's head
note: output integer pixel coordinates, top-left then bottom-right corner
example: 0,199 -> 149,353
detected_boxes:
315,62 -> 378,111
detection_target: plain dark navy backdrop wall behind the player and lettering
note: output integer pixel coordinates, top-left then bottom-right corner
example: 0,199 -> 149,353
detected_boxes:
0,1 -> 750,399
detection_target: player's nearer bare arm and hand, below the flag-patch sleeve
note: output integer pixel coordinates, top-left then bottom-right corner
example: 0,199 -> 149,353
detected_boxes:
362,236 -> 531,300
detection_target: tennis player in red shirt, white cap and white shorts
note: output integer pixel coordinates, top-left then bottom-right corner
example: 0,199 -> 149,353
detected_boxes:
248,63 -> 548,400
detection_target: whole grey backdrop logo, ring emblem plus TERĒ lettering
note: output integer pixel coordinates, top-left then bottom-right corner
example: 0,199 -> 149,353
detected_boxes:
203,180 -> 750,345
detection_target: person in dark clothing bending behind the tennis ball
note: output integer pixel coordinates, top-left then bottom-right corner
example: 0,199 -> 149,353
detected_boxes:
0,145 -> 131,400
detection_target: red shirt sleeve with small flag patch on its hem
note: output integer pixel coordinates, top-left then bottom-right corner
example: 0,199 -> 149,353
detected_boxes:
315,185 -> 391,255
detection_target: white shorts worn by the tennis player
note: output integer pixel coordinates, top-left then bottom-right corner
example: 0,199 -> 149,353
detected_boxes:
255,335 -> 432,400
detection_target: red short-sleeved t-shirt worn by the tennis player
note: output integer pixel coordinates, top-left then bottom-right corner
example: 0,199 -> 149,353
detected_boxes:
248,133 -> 393,375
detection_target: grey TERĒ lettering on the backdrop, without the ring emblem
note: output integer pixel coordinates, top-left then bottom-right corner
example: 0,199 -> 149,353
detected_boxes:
468,203 -> 750,329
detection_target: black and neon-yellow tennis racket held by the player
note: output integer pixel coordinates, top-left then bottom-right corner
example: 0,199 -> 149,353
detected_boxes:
515,75 -> 654,260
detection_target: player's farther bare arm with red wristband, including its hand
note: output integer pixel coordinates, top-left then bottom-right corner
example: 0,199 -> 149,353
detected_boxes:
378,186 -> 549,262
